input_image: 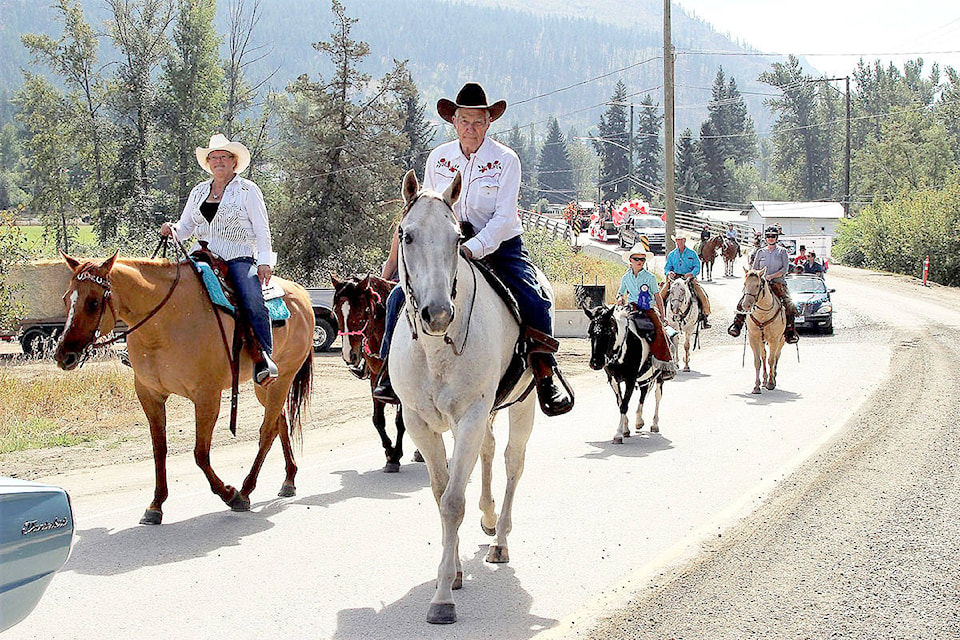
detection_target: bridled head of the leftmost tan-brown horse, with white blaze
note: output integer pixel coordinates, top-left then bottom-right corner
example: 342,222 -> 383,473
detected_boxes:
55,252 -> 119,371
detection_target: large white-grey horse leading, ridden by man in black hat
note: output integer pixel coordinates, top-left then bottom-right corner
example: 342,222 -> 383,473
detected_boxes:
388,171 -> 540,624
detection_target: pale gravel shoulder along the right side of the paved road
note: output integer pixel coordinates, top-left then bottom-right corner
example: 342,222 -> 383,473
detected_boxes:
567,269 -> 960,640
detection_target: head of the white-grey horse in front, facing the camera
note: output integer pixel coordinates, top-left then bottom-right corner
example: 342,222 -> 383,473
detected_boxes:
399,170 -> 462,336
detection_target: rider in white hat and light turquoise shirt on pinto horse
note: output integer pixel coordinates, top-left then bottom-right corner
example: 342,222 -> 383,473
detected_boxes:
617,242 -> 677,380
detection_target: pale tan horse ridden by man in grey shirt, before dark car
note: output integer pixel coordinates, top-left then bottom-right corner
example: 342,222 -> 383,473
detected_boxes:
737,267 -> 786,394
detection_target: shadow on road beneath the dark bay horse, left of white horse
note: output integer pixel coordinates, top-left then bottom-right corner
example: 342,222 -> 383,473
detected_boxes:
293,462 -> 430,507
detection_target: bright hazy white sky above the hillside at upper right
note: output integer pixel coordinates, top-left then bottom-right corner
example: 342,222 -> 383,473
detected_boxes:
674,0 -> 960,76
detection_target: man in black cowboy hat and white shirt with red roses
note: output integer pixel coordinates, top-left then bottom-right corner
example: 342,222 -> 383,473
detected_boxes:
374,82 -> 573,416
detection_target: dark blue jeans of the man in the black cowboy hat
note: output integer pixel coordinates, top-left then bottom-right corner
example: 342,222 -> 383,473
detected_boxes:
380,236 -> 553,358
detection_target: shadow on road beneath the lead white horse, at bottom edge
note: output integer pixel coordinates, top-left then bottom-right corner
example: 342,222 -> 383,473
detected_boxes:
332,545 -> 557,640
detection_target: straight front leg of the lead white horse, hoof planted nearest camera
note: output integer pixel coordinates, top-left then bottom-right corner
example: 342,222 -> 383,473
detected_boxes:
430,402 -> 489,624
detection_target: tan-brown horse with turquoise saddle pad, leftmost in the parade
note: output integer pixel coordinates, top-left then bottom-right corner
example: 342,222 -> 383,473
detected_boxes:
56,254 -> 314,524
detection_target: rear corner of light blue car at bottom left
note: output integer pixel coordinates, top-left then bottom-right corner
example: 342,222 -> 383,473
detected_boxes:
0,478 -> 73,632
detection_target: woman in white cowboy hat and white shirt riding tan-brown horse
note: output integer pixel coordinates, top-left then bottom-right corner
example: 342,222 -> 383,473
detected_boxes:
160,133 -> 278,385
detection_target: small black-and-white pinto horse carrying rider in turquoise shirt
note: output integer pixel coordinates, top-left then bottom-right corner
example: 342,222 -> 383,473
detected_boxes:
581,305 -> 673,444
